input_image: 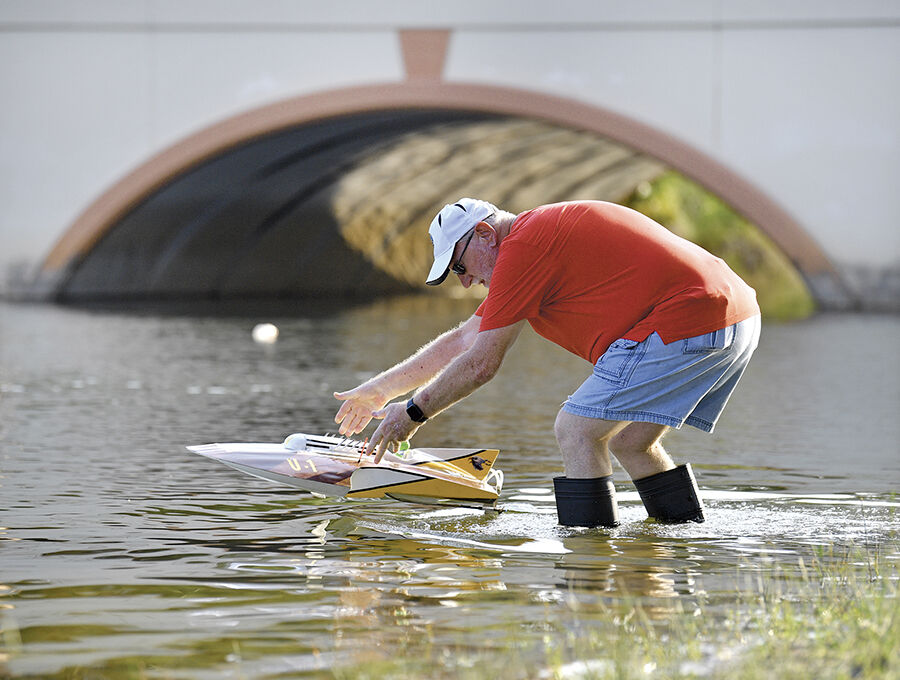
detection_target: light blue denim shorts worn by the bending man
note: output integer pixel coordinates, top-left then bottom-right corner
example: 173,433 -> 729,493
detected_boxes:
563,315 -> 760,432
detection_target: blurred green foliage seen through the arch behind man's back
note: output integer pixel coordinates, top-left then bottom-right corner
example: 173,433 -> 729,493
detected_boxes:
625,171 -> 815,320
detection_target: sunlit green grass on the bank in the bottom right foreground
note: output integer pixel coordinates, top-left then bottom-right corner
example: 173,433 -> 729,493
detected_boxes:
329,546 -> 900,680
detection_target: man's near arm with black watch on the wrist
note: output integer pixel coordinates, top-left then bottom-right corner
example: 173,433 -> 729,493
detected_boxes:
366,321 -> 525,463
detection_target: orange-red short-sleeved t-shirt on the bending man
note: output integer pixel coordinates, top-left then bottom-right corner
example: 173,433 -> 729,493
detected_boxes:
476,201 -> 759,363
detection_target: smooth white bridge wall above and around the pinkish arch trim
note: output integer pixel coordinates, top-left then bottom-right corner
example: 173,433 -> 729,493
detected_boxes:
0,0 -> 900,282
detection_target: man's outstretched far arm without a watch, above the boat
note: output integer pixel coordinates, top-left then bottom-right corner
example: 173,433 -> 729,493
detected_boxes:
334,314 -> 481,435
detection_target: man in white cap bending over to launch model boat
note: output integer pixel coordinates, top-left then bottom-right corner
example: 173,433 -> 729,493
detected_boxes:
334,198 -> 760,526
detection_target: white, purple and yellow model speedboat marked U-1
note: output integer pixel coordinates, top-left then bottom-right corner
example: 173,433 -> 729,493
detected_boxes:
187,433 -> 503,505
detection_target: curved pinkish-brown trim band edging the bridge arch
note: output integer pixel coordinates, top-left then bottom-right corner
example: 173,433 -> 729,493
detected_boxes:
42,79 -> 843,299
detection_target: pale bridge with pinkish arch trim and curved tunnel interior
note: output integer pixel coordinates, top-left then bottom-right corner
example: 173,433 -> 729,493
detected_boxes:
0,6 -> 900,307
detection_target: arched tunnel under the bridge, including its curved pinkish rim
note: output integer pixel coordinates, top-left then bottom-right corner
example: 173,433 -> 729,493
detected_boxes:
39,84 -> 839,310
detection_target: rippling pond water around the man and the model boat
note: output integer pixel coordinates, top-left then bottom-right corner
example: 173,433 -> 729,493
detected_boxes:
0,298 -> 900,678
